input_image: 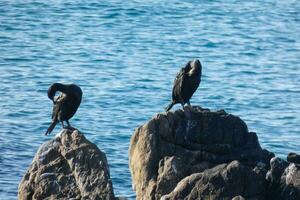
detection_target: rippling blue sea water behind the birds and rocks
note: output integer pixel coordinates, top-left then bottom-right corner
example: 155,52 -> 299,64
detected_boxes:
0,0 -> 300,199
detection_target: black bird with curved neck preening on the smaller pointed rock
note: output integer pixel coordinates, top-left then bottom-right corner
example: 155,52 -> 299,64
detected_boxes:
45,83 -> 82,135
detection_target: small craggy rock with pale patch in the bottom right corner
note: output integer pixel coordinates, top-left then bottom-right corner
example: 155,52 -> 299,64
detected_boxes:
266,154 -> 300,200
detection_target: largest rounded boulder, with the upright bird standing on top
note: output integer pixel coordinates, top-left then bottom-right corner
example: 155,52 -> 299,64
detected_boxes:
129,107 -> 274,199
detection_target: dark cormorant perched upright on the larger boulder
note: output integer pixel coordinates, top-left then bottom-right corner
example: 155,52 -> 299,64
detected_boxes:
166,59 -> 202,111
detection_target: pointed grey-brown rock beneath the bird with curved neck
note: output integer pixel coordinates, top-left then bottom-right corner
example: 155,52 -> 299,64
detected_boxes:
18,129 -> 115,200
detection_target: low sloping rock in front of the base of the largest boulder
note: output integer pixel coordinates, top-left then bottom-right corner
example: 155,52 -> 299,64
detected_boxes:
162,161 -> 266,200
